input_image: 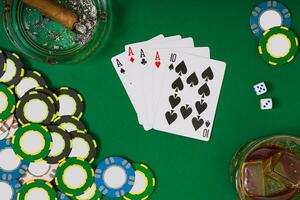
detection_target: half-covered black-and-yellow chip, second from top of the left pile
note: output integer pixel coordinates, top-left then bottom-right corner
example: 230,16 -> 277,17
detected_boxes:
15,71 -> 46,98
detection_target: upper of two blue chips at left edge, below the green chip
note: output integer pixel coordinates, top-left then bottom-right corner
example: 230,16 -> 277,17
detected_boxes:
0,139 -> 29,179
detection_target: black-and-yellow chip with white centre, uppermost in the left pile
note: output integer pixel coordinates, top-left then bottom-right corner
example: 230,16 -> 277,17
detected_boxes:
0,52 -> 24,87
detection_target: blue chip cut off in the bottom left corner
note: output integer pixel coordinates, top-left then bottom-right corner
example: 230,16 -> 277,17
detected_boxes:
0,173 -> 21,200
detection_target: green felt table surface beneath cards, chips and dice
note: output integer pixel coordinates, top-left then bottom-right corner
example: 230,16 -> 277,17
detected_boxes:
0,0 -> 300,200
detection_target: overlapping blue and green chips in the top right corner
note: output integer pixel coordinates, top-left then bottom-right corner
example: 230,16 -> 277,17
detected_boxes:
250,1 -> 299,65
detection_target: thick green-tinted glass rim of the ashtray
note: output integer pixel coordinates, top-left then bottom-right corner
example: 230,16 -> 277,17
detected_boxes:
2,0 -> 112,64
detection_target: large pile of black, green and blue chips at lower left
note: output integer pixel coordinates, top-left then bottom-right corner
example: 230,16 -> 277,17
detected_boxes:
0,51 -> 156,200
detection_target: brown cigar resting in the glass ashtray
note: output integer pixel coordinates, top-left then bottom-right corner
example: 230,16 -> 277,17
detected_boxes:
22,0 -> 78,29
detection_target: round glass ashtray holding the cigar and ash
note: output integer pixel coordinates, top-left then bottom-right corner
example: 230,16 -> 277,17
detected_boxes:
3,0 -> 111,64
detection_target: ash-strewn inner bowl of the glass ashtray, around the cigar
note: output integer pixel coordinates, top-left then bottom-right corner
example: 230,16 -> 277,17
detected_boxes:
22,0 -> 98,51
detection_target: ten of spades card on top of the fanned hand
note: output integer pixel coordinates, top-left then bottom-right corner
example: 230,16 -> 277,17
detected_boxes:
153,52 -> 226,141
